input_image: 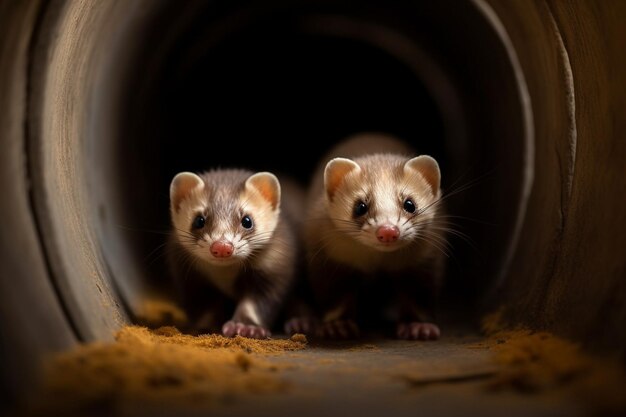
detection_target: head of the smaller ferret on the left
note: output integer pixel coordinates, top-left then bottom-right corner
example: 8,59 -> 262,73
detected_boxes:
170,170 -> 280,265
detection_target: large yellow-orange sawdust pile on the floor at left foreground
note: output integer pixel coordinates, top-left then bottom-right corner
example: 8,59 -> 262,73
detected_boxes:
34,326 -> 306,415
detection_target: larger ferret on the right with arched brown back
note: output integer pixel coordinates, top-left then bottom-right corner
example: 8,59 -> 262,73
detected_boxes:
298,134 -> 447,340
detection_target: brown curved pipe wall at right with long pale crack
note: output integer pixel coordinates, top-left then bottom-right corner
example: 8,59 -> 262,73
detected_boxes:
482,1 -> 626,352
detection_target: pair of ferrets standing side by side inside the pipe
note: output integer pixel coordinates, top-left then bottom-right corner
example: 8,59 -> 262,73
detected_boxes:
168,134 -> 445,340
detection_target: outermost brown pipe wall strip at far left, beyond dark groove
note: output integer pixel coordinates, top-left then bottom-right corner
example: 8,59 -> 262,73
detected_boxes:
0,1 -> 76,404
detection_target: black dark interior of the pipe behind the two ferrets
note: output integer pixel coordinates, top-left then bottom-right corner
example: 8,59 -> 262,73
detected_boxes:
106,2 -> 524,324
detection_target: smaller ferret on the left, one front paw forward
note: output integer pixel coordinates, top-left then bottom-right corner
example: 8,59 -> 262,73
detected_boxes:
168,169 -> 301,339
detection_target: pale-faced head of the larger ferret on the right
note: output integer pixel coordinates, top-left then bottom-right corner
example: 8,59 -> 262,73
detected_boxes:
324,154 -> 441,251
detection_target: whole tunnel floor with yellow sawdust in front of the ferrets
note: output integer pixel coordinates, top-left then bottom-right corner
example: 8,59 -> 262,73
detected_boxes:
26,316 -> 626,417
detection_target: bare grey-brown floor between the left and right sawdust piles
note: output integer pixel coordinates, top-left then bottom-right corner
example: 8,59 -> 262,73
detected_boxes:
214,335 -> 581,416
